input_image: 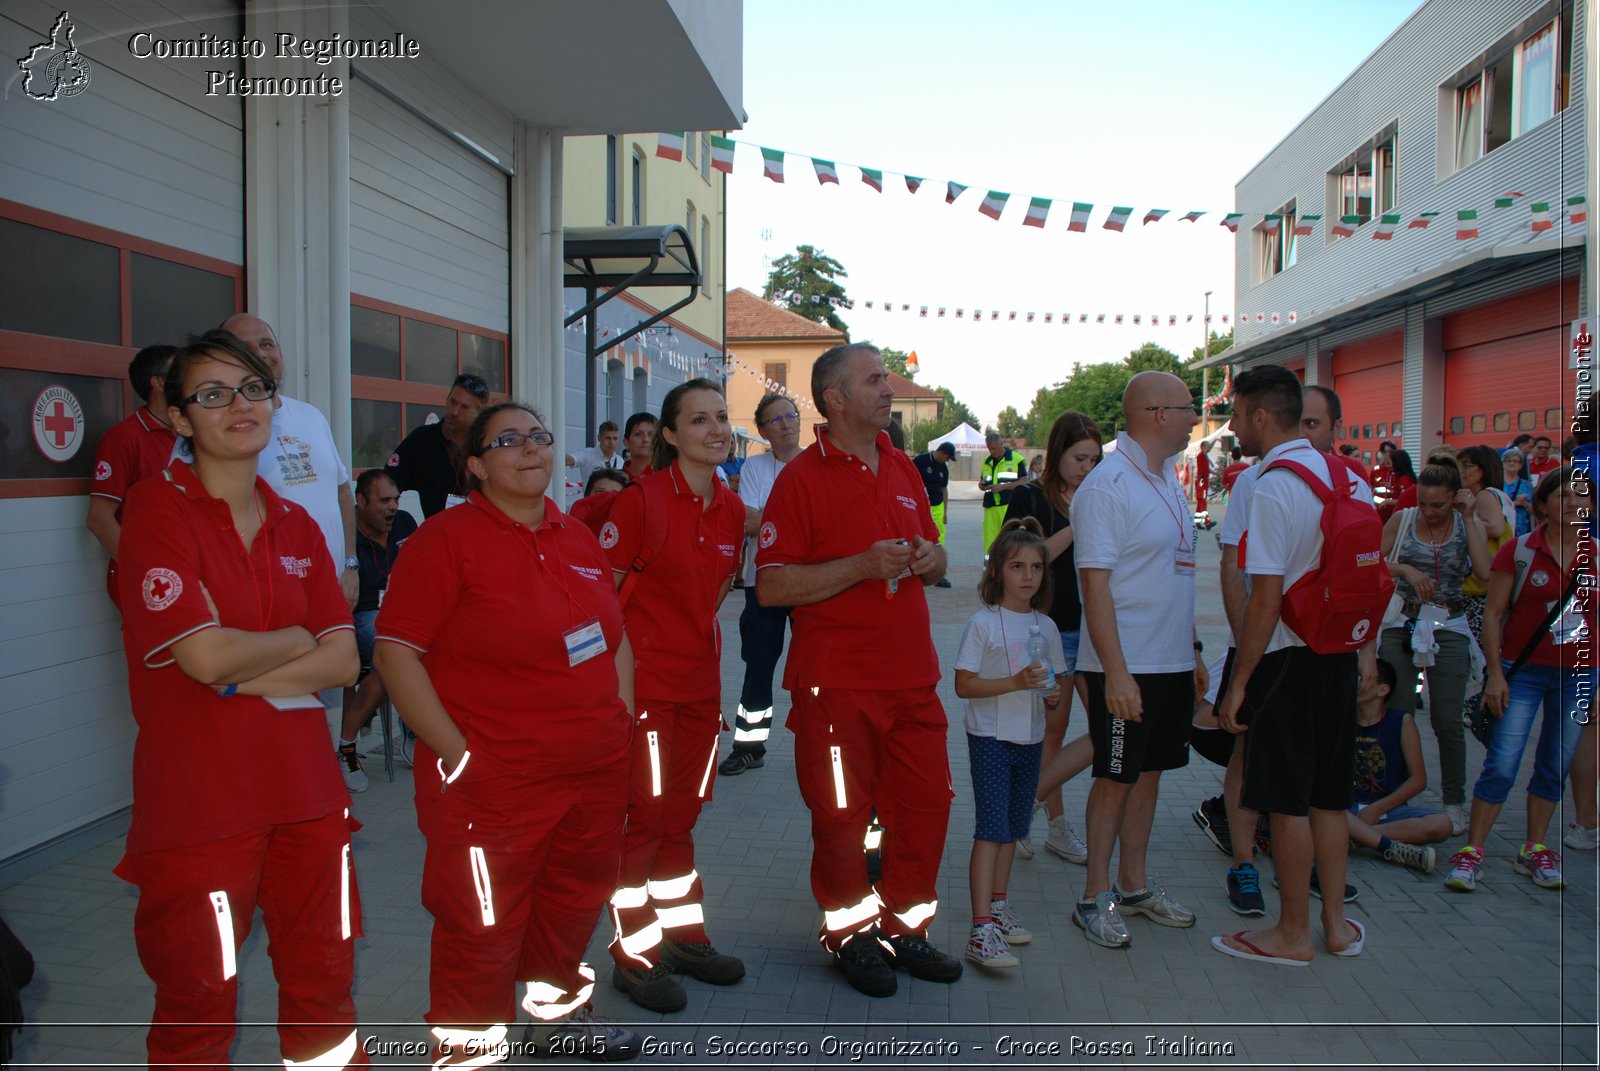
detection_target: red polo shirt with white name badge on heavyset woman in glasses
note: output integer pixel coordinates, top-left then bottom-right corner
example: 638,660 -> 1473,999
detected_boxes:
378,491 -> 637,848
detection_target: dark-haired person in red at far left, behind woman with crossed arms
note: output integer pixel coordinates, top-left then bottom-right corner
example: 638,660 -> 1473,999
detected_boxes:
83,346 -> 178,602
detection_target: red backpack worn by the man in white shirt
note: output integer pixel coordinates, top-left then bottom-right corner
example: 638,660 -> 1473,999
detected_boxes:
1240,455 -> 1395,655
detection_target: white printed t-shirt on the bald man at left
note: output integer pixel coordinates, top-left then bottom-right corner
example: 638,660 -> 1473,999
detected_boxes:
171,394 -> 350,576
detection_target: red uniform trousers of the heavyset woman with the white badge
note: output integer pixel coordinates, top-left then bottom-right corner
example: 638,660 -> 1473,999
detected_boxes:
422,762 -> 627,1037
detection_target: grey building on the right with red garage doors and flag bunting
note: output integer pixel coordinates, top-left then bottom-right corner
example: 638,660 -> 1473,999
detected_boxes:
1210,0 -> 1594,458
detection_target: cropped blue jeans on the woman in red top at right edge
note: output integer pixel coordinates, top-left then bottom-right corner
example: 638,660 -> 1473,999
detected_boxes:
1472,661 -> 1597,804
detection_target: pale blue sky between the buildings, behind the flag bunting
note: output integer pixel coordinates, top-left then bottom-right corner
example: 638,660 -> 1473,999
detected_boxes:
728,0 -> 1418,421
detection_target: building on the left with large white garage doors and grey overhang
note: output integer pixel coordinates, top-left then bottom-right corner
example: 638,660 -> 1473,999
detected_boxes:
0,0 -> 742,860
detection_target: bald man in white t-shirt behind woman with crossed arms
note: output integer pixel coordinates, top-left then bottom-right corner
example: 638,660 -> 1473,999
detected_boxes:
221,312 -> 362,607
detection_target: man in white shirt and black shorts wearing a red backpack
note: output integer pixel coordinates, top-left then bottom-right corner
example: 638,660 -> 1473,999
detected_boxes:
1211,367 -> 1392,967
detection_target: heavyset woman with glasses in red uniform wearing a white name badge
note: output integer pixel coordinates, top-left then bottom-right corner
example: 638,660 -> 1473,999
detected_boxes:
374,402 -> 638,1068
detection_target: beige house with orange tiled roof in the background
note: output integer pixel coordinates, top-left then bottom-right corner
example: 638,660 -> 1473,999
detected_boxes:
728,287 -> 845,447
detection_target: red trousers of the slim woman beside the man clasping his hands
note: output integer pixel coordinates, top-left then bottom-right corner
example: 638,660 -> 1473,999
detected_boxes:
611,698 -> 722,969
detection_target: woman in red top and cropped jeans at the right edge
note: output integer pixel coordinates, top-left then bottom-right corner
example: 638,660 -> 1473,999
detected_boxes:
1445,464 -> 1600,892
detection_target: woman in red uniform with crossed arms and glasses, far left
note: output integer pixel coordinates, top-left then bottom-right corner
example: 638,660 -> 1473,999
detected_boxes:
117,331 -> 366,1068
